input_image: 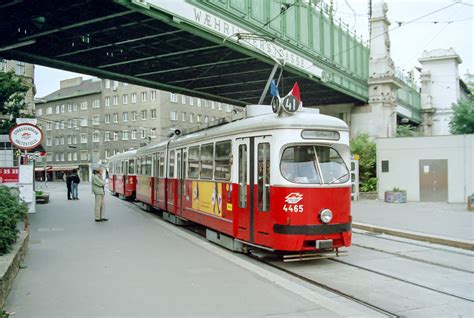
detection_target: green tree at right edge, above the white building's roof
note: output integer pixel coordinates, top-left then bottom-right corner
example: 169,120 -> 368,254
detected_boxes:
449,95 -> 474,135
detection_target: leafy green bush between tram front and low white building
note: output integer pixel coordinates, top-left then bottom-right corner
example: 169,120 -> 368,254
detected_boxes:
350,133 -> 377,192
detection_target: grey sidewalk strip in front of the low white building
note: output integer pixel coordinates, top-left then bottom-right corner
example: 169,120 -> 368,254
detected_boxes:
352,200 -> 474,242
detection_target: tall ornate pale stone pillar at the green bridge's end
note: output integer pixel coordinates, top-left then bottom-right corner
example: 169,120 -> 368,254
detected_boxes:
351,1 -> 401,137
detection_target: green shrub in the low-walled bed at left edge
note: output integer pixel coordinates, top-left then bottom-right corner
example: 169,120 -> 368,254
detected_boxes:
0,186 -> 28,255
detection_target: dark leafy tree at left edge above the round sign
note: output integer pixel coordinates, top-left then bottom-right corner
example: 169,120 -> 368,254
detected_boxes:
0,72 -> 29,134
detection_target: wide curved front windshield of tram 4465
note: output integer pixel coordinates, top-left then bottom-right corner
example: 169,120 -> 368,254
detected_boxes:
280,145 -> 349,184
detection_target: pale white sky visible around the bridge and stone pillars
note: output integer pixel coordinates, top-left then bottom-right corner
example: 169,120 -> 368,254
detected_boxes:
35,0 -> 474,98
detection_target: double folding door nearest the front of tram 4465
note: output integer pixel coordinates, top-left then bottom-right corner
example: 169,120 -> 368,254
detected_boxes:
236,136 -> 272,245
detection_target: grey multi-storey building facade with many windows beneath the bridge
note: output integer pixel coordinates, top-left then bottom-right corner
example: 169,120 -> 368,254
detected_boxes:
36,78 -> 234,180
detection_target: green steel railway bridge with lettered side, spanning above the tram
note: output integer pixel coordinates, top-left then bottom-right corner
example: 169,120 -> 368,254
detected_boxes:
0,0 -> 421,134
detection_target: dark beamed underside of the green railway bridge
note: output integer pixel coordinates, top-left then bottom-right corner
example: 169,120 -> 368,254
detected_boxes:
0,0 -> 361,105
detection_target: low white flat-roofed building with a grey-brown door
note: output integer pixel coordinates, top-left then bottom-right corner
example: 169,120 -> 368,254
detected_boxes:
376,135 -> 474,203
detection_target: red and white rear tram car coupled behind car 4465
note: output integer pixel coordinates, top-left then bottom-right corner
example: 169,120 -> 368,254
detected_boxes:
108,150 -> 137,199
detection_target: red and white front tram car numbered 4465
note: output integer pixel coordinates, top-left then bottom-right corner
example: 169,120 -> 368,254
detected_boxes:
109,106 -> 352,253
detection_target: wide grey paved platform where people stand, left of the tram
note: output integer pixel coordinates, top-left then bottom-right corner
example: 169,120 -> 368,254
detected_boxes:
5,183 -> 380,318
